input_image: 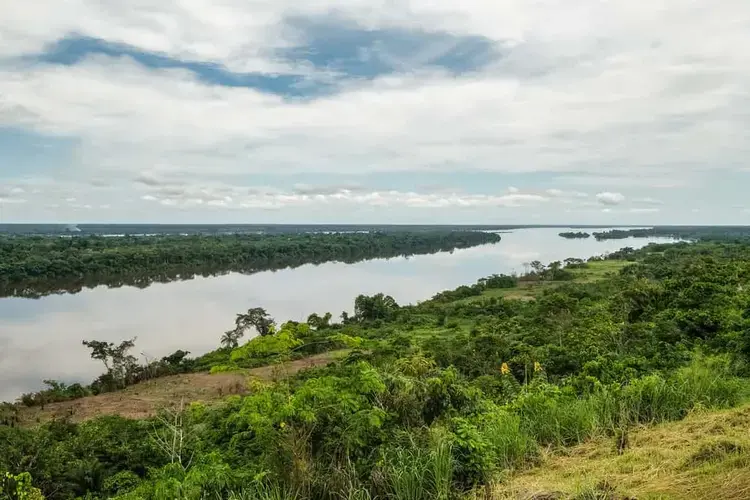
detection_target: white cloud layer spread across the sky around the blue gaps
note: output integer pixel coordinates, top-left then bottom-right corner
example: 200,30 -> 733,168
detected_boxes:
0,0 -> 750,221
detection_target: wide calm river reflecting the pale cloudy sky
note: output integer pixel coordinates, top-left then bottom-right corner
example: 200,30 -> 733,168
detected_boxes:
0,228 -> 680,401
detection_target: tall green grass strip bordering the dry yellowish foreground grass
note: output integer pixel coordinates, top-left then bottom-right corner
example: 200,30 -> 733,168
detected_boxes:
173,358 -> 746,500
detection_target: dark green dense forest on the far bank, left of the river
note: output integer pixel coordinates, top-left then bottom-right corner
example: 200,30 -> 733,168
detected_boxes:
0,230 -> 500,297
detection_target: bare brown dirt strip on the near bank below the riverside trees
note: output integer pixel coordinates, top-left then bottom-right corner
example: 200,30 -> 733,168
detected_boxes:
19,351 -> 345,425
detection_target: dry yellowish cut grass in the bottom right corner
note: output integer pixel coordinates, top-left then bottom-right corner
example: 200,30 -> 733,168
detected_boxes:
492,405 -> 750,500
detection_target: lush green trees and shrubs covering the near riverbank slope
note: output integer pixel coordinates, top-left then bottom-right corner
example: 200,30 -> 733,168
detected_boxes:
0,238 -> 750,500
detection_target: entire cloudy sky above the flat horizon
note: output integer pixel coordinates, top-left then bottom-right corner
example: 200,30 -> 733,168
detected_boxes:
0,0 -> 750,225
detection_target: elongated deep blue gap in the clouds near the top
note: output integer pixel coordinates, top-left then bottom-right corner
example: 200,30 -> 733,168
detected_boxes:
27,18 -> 497,98
